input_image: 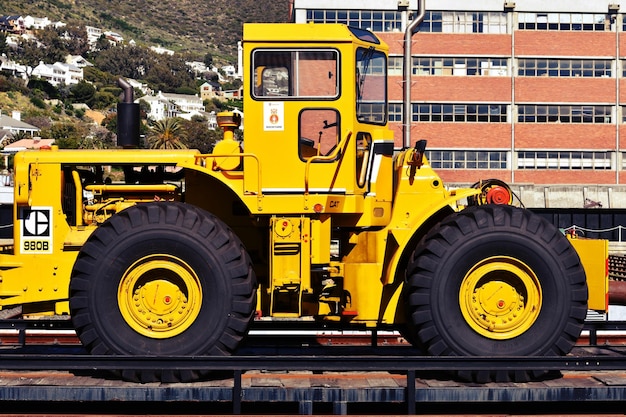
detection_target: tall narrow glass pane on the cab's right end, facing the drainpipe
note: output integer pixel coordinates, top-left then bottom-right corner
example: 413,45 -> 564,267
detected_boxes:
356,47 -> 387,125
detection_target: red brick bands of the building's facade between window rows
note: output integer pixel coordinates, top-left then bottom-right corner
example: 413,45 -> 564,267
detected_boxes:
378,30 -> 626,184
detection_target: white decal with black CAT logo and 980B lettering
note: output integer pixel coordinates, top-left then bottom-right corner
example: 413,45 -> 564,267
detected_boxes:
18,207 -> 52,254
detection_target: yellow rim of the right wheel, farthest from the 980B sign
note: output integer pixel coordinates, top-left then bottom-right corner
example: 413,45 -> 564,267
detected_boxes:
459,256 -> 542,340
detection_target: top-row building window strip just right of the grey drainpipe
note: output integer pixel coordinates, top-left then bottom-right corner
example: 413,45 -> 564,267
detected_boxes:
417,11 -> 506,33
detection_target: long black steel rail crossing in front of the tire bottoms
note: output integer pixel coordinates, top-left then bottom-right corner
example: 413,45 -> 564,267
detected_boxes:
0,347 -> 626,372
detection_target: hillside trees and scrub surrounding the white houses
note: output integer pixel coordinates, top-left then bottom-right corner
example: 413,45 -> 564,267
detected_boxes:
0,0 -> 288,153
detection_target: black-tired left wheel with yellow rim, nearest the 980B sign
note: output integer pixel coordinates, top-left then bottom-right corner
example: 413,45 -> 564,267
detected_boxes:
70,203 -> 256,382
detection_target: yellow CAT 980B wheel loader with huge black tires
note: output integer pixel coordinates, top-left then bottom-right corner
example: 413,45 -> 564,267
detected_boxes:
0,3 -> 608,381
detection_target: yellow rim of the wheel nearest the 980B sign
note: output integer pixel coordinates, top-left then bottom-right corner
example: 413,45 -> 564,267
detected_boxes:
117,255 -> 202,339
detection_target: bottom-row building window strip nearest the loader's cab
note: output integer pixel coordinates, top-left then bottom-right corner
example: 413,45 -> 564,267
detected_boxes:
426,150 -> 507,169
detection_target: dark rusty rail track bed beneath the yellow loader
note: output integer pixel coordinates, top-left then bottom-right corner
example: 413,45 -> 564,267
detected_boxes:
0,320 -> 626,414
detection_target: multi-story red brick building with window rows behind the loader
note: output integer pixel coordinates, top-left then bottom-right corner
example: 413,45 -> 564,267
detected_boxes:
292,0 -> 626,190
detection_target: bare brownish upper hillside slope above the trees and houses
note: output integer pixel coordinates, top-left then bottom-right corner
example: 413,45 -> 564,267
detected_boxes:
0,0 -> 289,61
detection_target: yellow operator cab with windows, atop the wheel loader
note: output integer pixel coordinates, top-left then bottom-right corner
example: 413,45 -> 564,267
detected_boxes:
239,24 -> 393,205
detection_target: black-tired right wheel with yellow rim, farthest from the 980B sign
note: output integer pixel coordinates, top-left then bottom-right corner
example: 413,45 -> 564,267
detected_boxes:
406,205 -> 587,382
